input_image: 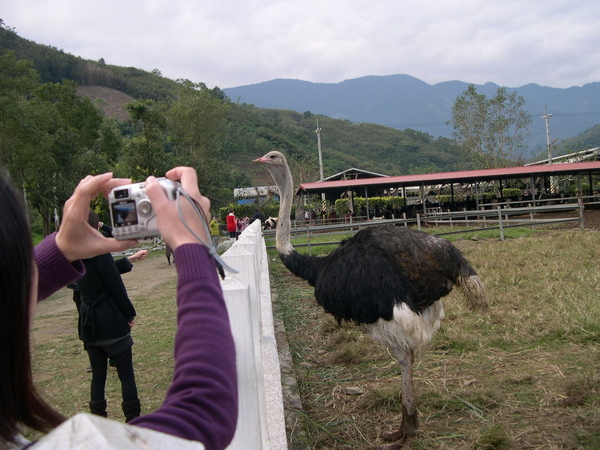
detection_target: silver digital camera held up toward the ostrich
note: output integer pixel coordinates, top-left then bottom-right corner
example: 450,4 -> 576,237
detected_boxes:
108,178 -> 179,240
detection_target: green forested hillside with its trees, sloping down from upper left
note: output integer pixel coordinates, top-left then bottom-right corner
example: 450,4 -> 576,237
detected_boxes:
0,20 -> 502,232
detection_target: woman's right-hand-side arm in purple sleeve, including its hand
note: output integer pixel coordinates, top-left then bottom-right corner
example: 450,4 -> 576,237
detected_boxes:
130,167 -> 237,450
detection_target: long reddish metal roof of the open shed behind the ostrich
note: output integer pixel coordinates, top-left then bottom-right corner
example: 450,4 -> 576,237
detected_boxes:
298,161 -> 600,194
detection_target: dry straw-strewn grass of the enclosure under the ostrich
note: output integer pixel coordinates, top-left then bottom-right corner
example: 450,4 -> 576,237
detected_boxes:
271,231 -> 600,449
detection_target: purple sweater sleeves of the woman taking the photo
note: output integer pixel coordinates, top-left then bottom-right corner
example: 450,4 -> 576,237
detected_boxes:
35,235 -> 238,450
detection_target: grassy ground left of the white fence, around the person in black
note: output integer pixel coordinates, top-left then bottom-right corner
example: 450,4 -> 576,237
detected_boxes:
25,253 -> 177,439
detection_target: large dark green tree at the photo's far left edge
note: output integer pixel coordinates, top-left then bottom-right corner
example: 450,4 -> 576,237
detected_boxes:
0,53 -> 109,234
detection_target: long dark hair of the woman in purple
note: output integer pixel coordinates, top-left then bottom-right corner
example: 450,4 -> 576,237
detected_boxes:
0,169 -> 65,442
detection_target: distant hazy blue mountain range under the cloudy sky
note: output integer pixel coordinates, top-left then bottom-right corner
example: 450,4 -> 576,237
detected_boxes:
223,75 -> 600,155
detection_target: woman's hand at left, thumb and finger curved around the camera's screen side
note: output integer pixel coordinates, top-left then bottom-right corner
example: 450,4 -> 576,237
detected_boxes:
56,173 -> 138,262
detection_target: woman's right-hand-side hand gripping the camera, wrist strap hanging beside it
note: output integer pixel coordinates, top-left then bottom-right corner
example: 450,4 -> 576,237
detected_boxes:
146,167 -> 210,251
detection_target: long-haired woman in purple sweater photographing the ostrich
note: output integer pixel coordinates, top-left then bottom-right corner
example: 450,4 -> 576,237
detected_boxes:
0,167 -> 237,449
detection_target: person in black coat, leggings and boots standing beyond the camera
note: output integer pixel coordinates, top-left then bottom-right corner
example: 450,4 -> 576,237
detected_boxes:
77,211 -> 141,422
